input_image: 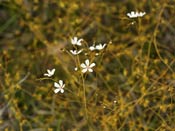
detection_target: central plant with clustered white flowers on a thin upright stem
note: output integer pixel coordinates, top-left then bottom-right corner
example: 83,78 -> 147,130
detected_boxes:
63,37 -> 107,120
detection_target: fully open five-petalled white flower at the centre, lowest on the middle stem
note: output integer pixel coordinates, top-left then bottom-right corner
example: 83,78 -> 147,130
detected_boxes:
81,59 -> 95,73
